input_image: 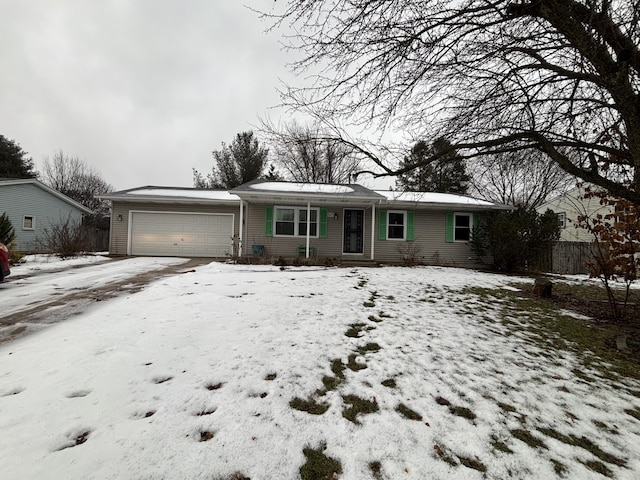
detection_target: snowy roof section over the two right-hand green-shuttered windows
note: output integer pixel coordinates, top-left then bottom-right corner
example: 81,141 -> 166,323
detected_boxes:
376,190 -> 513,210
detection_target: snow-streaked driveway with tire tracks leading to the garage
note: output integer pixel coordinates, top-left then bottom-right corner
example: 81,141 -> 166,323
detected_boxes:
0,257 -> 212,343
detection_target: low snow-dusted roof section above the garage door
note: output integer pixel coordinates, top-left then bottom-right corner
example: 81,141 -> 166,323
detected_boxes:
100,185 -> 240,205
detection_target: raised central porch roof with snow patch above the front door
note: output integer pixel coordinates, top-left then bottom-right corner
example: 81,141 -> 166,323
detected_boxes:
231,180 -> 384,203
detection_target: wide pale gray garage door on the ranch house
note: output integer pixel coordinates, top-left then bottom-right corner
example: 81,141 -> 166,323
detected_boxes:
131,212 -> 233,257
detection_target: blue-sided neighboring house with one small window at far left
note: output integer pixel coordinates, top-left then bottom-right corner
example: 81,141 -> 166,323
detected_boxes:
0,178 -> 93,253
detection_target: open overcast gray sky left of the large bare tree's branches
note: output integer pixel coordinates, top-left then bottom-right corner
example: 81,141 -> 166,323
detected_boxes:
0,0 -> 292,190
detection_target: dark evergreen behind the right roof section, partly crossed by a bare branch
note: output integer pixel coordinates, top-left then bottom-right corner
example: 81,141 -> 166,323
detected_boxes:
396,138 -> 471,195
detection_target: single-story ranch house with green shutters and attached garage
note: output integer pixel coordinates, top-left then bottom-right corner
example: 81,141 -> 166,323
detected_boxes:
101,180 -> 509,265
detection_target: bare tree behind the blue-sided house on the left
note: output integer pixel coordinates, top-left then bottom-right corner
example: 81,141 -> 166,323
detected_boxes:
40,150 -> 113,217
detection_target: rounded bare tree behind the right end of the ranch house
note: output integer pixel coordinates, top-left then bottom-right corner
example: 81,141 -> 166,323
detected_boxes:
470,151 -> 576,209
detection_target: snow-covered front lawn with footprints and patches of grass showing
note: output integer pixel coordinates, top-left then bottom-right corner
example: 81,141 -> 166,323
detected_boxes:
0,263 -> 640,480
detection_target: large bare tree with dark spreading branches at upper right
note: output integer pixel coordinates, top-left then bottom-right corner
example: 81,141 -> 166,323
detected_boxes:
265,0 -> 640,203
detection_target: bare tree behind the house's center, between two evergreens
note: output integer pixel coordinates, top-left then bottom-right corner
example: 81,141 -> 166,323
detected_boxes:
263,121 -> 361,183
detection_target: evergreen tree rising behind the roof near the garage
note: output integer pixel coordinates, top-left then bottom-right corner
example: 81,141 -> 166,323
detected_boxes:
193,131 -> 269,189
